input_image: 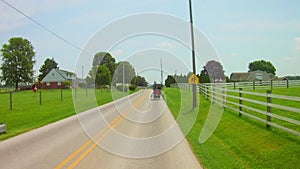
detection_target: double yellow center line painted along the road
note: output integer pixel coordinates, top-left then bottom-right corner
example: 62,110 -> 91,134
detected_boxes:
55,89 -> 148,169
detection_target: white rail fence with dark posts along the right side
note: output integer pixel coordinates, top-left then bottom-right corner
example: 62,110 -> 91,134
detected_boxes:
199,83 -> 300,136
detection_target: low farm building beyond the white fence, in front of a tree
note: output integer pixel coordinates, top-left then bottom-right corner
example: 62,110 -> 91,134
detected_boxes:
230,70 -> 275,82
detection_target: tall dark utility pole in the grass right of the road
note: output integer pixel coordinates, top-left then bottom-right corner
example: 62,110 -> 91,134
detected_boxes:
189,0 -> 197,108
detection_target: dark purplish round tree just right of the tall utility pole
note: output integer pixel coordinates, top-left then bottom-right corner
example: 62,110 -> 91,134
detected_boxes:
205,60 -> 225,82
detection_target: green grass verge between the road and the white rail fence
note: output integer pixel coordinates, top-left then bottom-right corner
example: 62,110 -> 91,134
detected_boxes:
164,88 -> 300,169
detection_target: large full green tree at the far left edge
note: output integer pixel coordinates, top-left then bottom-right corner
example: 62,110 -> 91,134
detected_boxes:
1,37 -> 35,90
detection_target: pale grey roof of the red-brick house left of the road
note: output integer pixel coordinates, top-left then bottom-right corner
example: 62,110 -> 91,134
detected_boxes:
42,69 -> 76,82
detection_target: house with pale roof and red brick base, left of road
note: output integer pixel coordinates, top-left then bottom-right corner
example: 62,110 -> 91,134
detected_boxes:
42,69 -> 76,89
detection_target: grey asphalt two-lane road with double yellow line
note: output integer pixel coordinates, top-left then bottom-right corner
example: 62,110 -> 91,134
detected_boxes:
0,90 -> 201,169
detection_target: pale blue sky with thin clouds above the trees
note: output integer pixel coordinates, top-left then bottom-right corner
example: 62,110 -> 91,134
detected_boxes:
0,0 -> 300,82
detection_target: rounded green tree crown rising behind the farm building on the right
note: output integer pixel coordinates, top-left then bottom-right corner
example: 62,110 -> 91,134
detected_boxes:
248,60 -> 276,75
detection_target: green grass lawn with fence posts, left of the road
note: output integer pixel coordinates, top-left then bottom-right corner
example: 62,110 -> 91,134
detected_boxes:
0,89 -> 137,141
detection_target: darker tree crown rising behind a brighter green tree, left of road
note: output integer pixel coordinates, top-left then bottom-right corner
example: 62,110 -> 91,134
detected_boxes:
93,52 -> 116,76
